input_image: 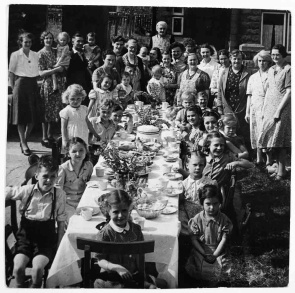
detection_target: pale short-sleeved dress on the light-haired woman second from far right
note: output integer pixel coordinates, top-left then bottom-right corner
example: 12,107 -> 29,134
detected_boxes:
247,71 -> 268,149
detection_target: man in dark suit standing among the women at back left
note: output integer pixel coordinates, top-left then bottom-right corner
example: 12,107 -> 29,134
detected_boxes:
67,33 -> 92,106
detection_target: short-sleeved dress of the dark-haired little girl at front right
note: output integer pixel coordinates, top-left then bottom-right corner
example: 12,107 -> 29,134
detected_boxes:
185,211 -> 232,282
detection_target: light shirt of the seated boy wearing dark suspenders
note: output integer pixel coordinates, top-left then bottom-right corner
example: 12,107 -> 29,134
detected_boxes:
5,183 -> 67,222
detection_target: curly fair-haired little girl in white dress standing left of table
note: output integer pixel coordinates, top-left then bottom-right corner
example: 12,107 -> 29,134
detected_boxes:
59,84 -> 99,153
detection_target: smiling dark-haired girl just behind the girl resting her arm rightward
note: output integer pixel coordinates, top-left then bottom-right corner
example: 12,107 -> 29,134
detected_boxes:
193,109 -> 220,151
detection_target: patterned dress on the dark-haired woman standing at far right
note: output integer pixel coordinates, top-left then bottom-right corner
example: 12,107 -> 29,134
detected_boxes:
259,63 -> 291,148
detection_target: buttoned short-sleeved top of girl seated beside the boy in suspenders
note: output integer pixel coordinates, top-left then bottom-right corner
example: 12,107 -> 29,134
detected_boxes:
57,160 -> 93,197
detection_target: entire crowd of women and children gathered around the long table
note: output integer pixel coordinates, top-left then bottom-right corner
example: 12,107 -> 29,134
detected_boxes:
7,21 -> 291,288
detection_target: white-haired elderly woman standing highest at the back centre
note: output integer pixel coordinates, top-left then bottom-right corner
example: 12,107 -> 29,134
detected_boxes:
150,21 -> 174,53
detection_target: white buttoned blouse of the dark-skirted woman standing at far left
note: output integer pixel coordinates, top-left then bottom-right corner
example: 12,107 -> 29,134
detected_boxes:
9,48 -> 39,77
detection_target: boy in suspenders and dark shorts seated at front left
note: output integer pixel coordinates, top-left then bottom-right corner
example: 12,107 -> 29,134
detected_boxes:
6,155 -> 67,288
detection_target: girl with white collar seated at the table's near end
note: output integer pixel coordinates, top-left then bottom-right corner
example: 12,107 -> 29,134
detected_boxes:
94,189 -> 165,289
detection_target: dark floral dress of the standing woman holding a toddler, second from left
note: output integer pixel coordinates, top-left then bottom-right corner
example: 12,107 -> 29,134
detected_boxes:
38,49 -> 66,122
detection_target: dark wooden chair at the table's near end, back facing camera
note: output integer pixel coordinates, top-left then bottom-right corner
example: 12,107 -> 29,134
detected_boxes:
77,237 -> 155,288
